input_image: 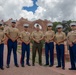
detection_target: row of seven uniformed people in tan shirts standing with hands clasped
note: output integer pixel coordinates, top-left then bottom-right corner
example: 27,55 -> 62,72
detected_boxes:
0,20 -> 76,70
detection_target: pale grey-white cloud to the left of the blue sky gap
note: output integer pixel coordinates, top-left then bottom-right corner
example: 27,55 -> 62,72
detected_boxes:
0,0 -> 33,20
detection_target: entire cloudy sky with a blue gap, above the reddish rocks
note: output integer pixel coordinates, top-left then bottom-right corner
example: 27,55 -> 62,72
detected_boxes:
0,0 -> 76,21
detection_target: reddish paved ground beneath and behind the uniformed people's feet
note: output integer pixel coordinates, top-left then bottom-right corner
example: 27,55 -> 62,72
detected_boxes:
0,46 -> 76,75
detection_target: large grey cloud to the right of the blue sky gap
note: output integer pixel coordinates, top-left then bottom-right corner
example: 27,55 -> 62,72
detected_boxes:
37,0 -> 76,21
